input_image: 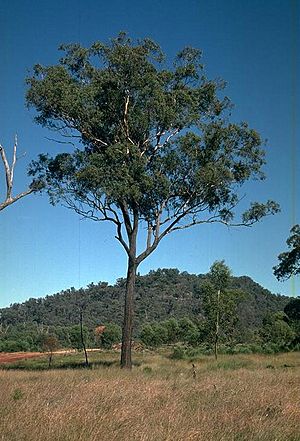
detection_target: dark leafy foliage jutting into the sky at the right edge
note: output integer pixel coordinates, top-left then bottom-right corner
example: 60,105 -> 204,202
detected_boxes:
273,224 -> 300,280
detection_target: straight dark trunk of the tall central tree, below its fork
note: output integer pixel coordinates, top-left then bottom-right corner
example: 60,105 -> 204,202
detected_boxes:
121,257 -> 137,369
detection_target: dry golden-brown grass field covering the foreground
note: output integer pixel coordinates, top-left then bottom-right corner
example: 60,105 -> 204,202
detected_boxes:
0,352 -> 300,441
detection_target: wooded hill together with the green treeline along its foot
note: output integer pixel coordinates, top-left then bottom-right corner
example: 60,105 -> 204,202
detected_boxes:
0,269 -> 295,351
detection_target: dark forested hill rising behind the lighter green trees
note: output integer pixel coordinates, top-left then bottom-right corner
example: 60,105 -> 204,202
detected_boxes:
0,269 -> 289,329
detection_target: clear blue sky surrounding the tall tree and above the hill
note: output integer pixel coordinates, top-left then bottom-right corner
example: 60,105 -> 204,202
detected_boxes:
0,0 -> 300,307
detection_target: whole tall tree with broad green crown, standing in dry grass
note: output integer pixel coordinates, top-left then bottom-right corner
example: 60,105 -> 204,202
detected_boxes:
27,33 -> 278,368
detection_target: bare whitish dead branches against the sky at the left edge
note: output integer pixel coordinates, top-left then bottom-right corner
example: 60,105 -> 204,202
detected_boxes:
0,135 -> 35,211
